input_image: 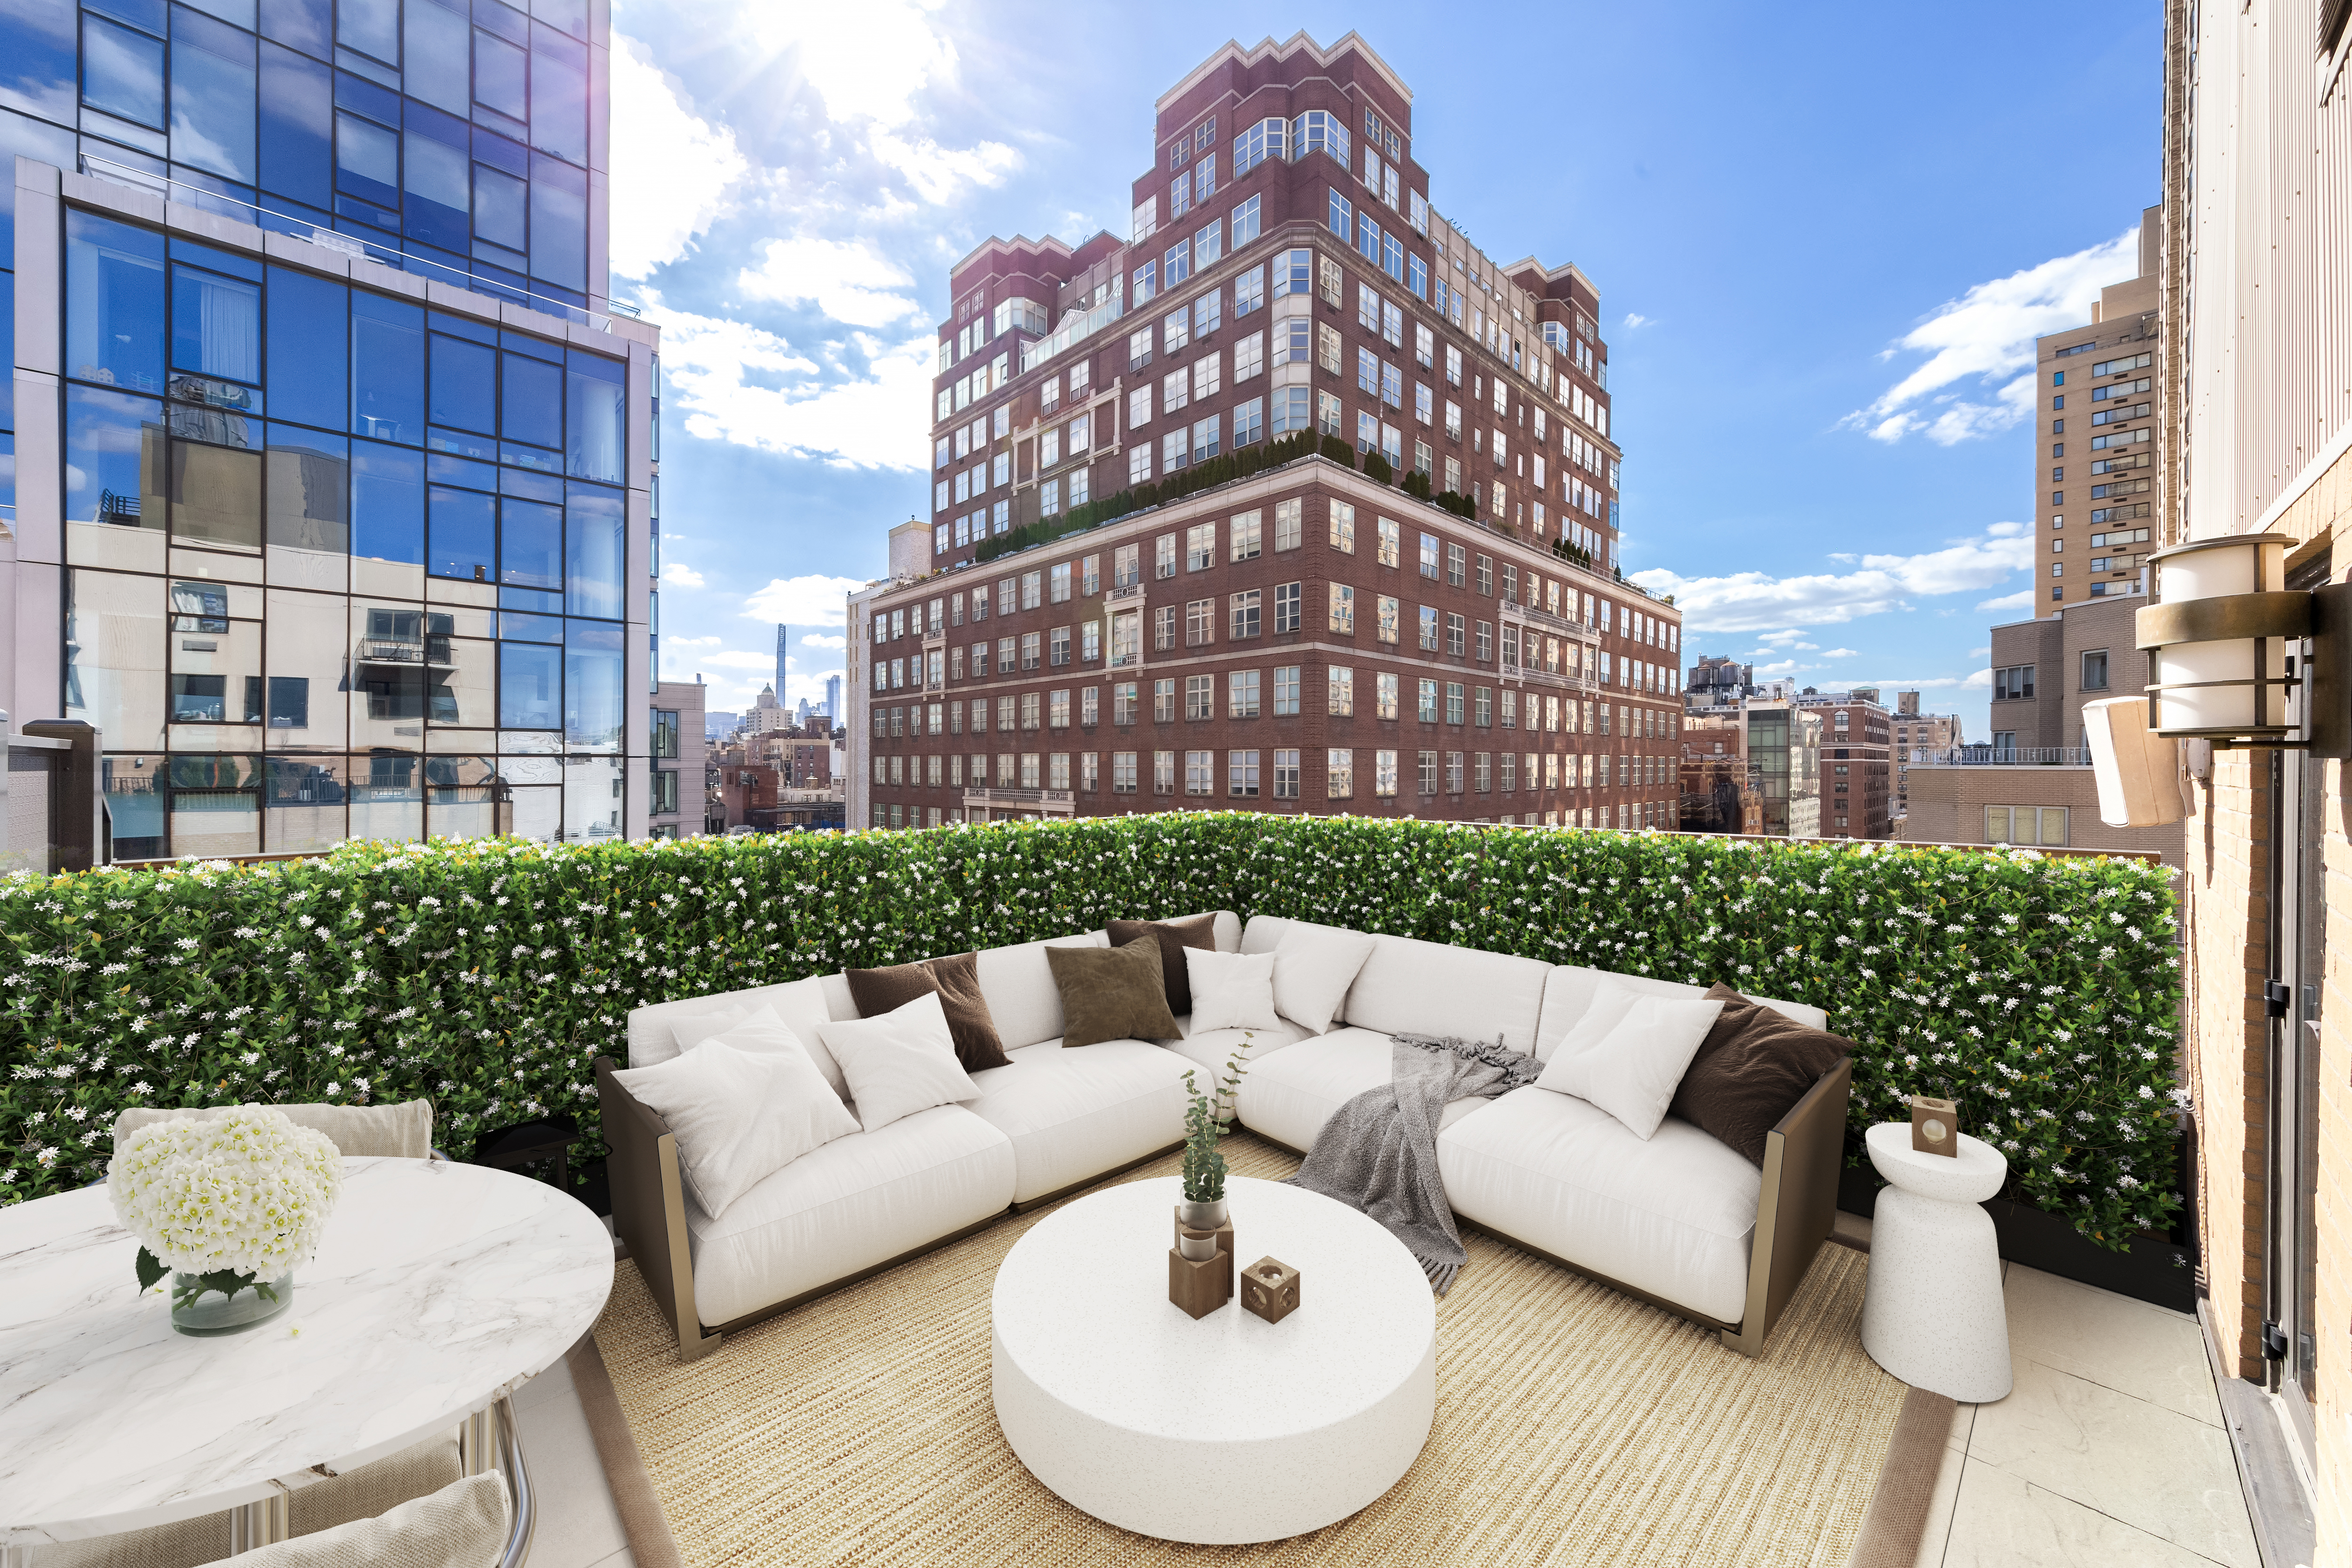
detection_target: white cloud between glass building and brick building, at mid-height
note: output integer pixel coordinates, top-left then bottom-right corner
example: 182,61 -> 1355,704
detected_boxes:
647,289 -> 936,470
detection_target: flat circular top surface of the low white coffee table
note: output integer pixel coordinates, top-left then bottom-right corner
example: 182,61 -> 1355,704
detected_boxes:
990,1176 -> 1437,1443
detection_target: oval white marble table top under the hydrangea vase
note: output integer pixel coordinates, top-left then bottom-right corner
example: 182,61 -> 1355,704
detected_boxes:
0,1159 -> 612,1547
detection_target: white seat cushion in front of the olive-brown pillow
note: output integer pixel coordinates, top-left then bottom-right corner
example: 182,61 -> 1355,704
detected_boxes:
967,1039 -> 1207,1203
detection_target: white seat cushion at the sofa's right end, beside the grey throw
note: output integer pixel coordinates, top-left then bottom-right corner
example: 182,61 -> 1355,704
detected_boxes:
1421,1079 -> 1764,1323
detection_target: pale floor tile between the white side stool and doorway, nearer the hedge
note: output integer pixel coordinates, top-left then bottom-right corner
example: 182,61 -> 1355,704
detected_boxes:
2006,1265 -> 2223,1427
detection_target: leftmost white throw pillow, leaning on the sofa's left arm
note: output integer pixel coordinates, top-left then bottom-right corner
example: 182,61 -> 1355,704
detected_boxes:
614,1009 -> 858,1220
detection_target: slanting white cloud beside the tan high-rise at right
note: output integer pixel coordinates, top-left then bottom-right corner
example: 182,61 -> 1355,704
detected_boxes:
1842,228 -> 2140,446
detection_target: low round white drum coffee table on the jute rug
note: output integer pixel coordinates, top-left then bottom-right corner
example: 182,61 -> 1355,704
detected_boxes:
990,1176 -> 1437,1544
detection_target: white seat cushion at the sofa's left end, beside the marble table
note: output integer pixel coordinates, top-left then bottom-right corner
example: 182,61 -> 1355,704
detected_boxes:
687,1105 -> 1014,1323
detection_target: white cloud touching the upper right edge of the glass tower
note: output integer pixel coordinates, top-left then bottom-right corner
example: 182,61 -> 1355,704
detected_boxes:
612,33 -> 750,278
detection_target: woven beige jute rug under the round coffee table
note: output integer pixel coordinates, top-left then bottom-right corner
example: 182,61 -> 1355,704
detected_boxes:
576,1136 -> 1950,1568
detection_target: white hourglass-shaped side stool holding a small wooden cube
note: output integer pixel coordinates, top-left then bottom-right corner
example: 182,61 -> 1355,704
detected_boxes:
1863,1122 -> 2011,1403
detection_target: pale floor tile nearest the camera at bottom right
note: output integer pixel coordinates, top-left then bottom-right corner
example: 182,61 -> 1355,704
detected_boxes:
1962,1359 -> 2260,1568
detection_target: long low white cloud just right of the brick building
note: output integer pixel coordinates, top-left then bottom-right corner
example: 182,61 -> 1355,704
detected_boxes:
1632,533 -> 2032,642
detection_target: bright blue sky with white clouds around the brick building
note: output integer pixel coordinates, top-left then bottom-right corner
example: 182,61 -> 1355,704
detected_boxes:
614,0 -> 2161,738
